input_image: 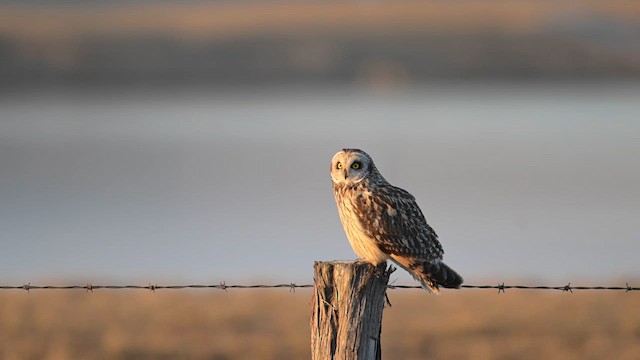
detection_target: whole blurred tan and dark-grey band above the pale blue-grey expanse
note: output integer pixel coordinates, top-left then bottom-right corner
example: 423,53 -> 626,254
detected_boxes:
0,0 -> 640,85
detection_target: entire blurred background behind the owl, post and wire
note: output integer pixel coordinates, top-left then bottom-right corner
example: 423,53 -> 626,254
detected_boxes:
0,0 -> 640,359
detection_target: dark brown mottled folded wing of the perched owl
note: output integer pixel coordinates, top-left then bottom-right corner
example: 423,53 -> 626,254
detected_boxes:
355,185 -> 444,261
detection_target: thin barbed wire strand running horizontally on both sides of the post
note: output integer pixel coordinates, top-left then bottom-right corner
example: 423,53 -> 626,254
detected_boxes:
0,281 -> 640,294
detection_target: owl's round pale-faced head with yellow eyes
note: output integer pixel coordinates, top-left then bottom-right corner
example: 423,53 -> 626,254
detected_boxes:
331,149 -> 377,185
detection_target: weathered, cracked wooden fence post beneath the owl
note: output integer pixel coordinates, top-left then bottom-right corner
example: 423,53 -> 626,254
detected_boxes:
311,261 -> 394,360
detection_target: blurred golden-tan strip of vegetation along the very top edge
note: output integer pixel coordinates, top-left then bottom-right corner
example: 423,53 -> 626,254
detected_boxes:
0,0 -> 640,41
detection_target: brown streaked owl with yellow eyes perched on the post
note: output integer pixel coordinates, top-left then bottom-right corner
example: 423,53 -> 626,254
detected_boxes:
331,149 -> 462,294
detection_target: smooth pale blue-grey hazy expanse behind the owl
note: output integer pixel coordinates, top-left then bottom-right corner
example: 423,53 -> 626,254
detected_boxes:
0,85 -> 640,284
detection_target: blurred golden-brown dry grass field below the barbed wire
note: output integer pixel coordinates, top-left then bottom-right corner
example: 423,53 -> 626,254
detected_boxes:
0,289 -> 640,360
